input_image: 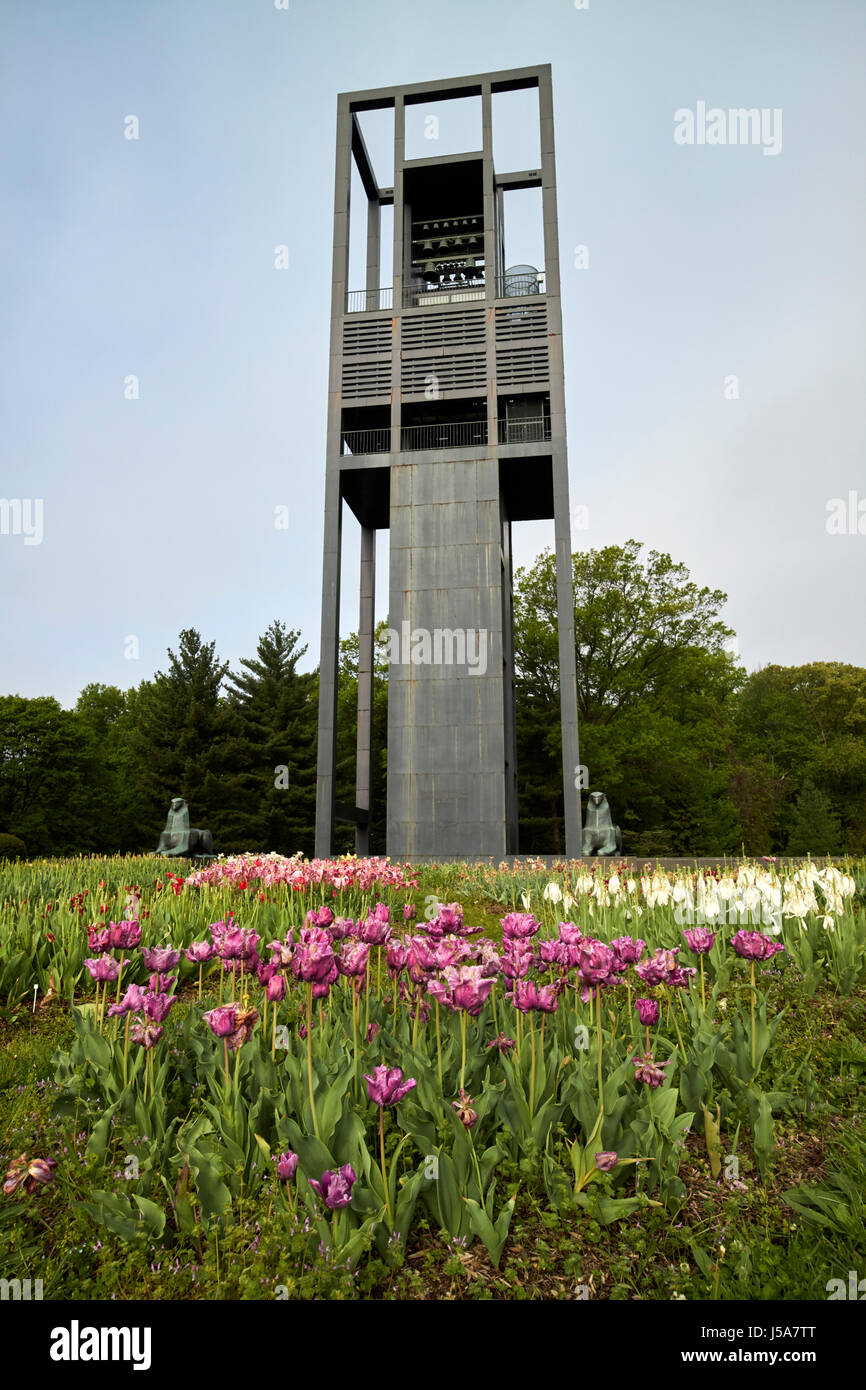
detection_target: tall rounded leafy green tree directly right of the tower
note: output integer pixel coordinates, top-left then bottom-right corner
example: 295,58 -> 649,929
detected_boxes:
514,541 -> 741,853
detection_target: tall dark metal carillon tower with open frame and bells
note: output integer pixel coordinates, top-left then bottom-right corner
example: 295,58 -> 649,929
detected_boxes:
316,65 -> 581,860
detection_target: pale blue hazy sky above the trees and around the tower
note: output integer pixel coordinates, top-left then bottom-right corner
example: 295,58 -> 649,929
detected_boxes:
0,0 -> 866,705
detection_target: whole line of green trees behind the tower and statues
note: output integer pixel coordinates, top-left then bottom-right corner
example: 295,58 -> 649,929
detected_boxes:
0,541 -> 866,856
